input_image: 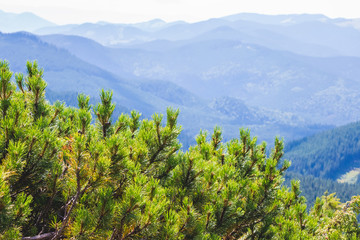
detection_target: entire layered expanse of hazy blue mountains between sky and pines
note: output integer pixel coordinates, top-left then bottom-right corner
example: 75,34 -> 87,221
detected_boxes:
0,9 -> 360,146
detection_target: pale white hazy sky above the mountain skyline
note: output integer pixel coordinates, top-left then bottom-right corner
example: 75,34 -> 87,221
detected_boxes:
0,0 -> 360,24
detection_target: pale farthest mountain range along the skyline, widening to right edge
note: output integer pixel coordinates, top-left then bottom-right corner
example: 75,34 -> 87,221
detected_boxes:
35,14 -> 360,57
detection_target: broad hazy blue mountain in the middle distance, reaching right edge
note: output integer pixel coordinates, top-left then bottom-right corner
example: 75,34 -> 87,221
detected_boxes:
41,29 -> 360,125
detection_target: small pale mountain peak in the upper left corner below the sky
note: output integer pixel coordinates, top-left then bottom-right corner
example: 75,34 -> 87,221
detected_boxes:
0,10 -> 56,32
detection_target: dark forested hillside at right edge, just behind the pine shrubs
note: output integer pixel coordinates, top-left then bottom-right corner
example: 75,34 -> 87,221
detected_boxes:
285,122 -> 360,180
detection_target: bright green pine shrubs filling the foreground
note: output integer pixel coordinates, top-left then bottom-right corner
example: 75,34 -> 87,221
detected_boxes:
0,61 -> 360,240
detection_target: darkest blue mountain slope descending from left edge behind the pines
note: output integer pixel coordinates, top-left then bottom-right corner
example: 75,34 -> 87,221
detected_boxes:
0,32 -> 160,113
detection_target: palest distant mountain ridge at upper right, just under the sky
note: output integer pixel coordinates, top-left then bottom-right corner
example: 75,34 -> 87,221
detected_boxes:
222,13 -> 360,56
